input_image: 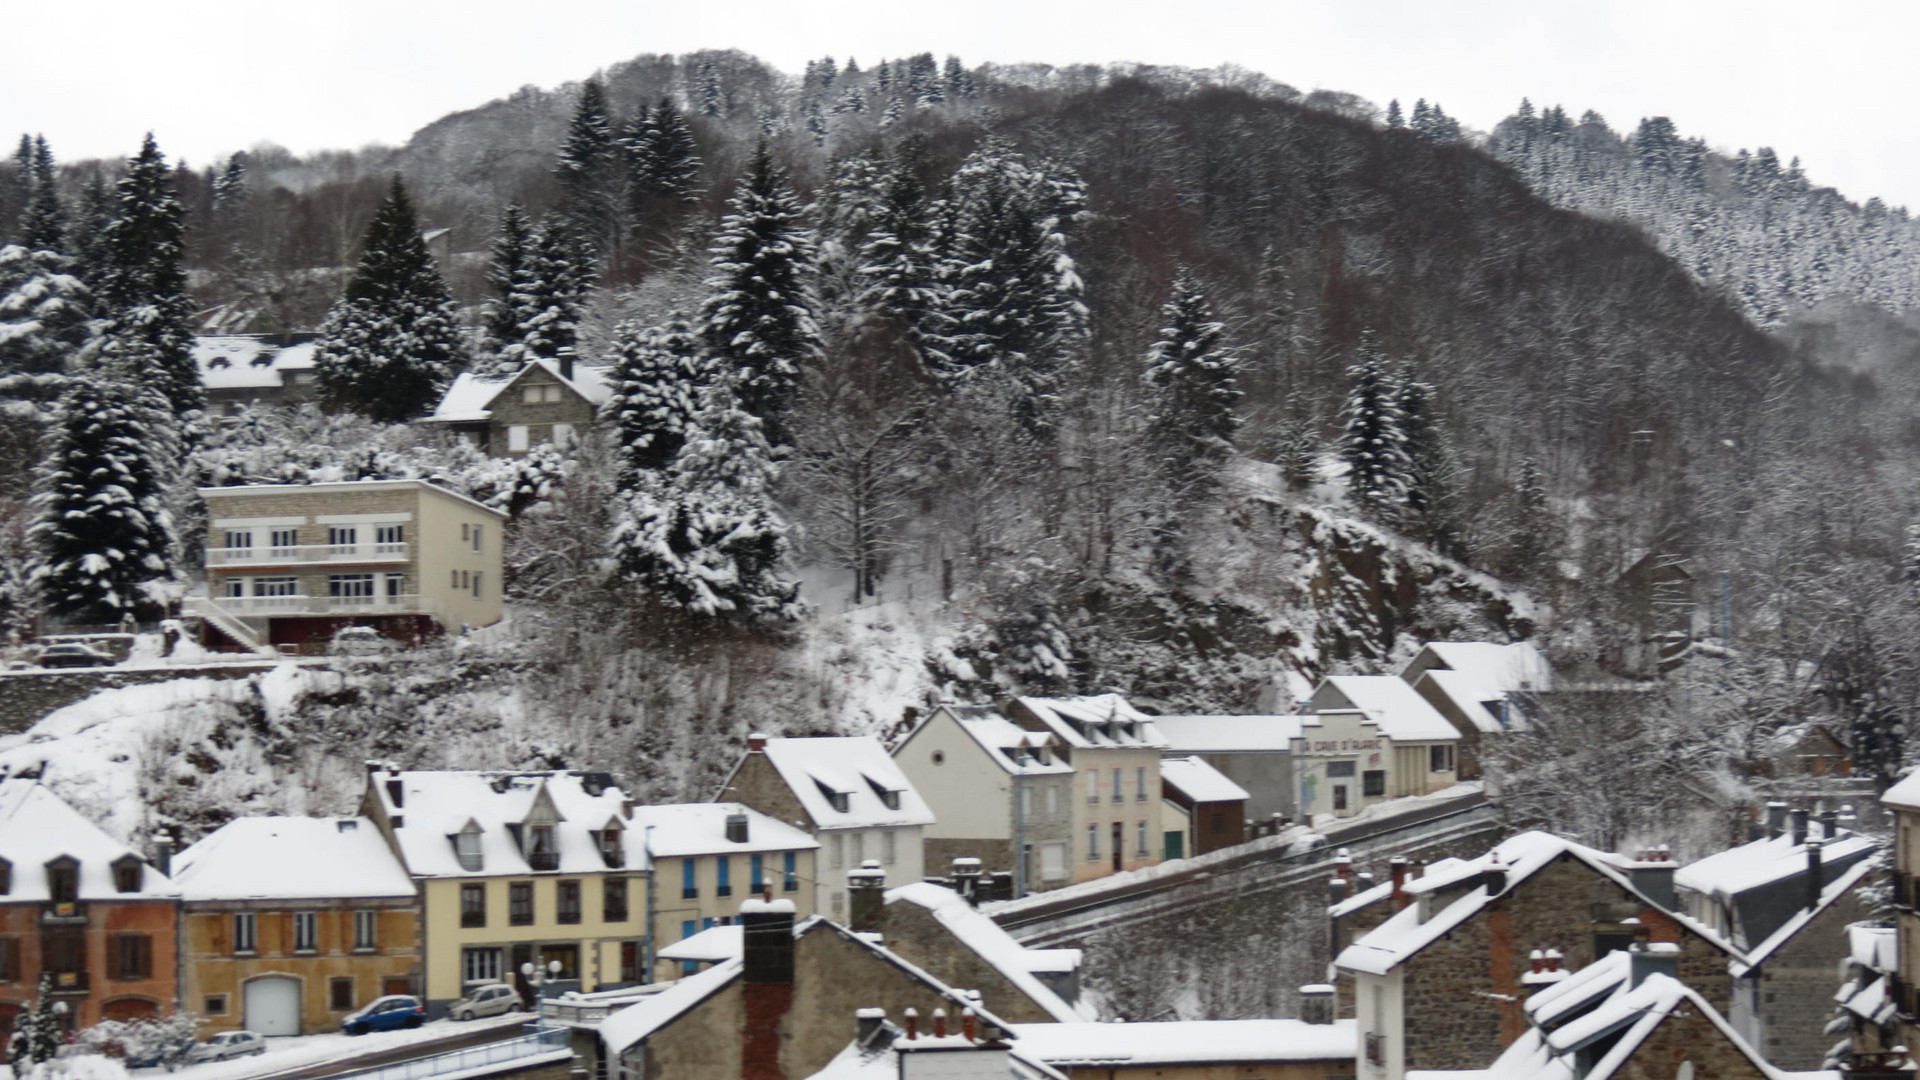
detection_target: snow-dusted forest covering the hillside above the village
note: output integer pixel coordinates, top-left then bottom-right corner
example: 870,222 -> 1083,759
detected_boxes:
0,52 -> 1920,853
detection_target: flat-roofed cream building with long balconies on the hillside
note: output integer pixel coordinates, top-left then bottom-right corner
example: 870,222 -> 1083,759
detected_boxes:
186,480 -> 507,651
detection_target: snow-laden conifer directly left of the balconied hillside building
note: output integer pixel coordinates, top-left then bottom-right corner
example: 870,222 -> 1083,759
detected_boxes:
27,359 -> 179,623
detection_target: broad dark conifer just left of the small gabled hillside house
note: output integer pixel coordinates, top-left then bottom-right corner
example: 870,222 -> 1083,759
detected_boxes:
313,173 -> 465,423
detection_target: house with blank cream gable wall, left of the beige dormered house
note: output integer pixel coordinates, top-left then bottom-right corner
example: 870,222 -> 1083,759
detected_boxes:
893,705 -> 1073,896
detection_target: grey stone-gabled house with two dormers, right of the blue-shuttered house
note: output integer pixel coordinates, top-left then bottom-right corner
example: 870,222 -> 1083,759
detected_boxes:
714,734 -> 933,914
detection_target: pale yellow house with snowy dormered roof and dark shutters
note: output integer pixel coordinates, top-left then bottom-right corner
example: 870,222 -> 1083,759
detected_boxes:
361,765 -> 649,1017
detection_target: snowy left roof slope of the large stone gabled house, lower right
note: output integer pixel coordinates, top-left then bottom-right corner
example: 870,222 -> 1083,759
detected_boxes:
1334,830 -> 1634,974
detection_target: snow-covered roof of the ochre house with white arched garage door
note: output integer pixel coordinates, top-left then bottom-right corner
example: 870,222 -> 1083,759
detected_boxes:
173,817 -> 415,901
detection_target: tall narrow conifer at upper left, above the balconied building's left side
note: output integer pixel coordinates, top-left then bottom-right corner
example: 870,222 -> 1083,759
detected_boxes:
94,135 -> 207,420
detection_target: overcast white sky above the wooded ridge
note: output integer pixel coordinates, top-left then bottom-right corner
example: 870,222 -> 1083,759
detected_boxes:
0,0 -> 1920,209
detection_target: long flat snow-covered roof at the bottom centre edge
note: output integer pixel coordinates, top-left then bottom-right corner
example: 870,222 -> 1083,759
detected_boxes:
1014,1020 -> 1359,1068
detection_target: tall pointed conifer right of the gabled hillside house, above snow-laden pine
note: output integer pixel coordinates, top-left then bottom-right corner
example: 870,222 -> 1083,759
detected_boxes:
701,140 -> 822,448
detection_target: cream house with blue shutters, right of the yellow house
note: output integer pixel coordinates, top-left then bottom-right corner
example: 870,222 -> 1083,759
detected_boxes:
628,803 -> 820,978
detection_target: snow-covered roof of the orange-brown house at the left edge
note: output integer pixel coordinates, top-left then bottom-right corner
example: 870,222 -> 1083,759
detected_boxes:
0,778 -> 177,903
